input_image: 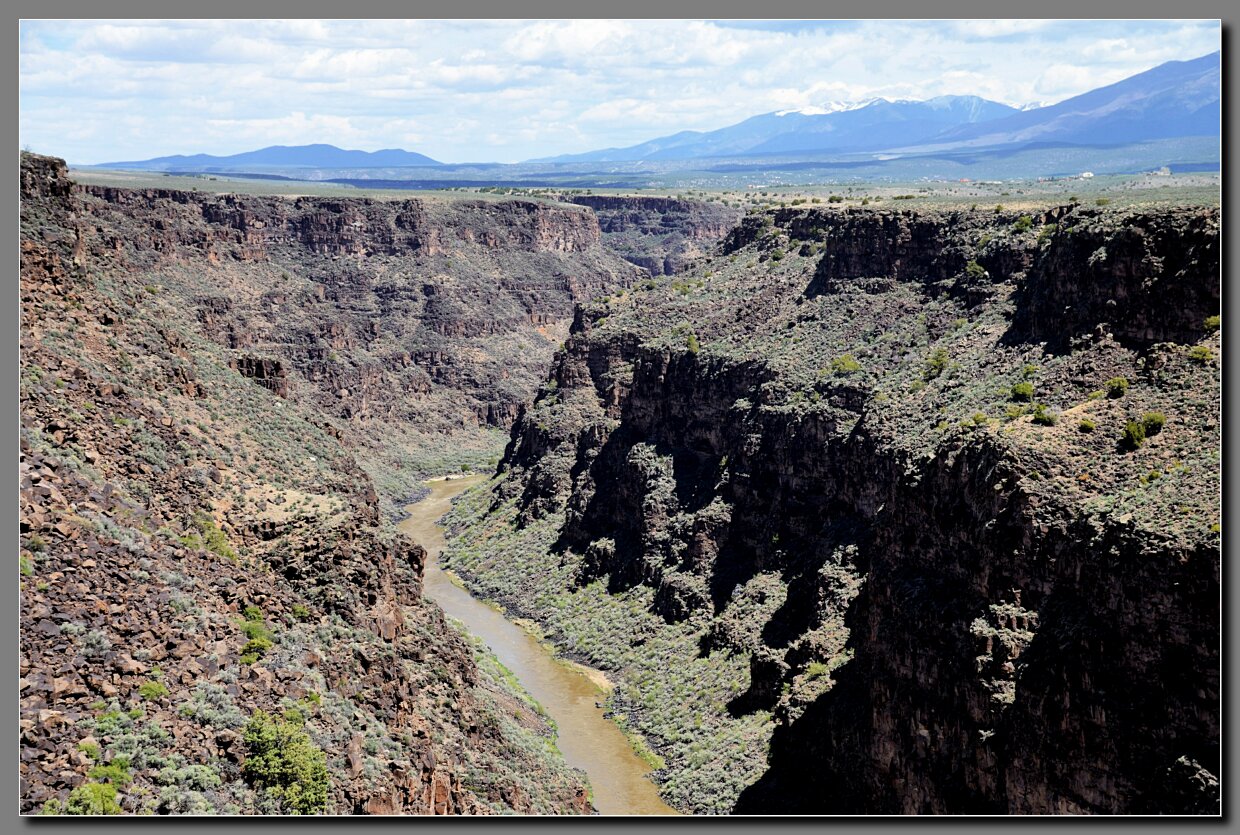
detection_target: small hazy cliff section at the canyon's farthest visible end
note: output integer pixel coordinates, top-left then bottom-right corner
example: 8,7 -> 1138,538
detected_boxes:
564,195 -> 744,275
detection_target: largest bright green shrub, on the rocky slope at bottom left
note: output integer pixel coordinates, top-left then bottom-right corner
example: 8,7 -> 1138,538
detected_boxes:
242,711 -> 330,815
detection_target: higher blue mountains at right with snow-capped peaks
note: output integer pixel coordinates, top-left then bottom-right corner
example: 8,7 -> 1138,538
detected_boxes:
532,52 -> 1221,163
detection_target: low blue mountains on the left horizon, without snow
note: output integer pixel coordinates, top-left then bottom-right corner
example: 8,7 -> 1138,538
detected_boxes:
94,144 -> 441,171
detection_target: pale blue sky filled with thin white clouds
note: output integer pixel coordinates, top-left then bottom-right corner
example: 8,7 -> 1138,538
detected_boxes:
19,20 -> 1220,164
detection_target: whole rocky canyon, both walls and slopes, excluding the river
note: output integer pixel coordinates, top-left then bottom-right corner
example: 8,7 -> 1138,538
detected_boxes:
21,154 -> 1221,814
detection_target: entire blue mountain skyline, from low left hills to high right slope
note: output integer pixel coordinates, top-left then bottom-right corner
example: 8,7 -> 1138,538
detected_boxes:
92,52 -> 1221,177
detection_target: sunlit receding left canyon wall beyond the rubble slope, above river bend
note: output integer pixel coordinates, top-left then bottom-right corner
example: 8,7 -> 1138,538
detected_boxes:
66,173 -> 644,512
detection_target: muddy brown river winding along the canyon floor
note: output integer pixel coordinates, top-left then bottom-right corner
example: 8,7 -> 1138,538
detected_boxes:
401,475 -> 677,815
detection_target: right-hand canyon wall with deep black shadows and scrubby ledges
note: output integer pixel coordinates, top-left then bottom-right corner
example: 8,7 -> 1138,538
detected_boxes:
451,198 -> 1220,814
